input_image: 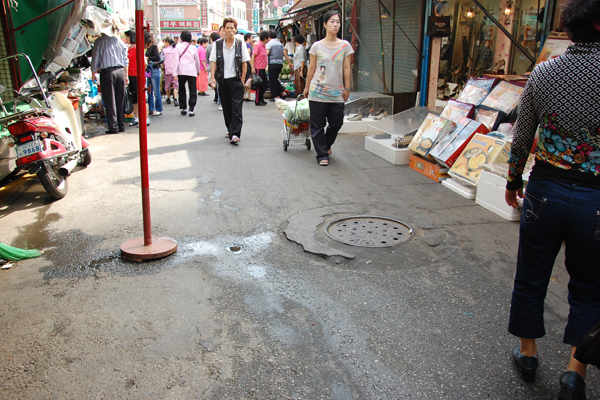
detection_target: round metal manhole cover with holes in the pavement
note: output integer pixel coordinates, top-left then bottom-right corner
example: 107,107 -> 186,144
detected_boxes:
325,215 -> 412,247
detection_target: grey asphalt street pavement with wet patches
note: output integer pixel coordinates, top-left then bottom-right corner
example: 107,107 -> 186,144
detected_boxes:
0,89 -> 600,400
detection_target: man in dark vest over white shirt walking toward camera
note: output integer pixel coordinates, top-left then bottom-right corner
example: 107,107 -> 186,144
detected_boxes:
210,18 -> 250,144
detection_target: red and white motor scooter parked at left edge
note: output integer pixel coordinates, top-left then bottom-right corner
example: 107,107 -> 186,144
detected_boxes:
0,53 -> 92,200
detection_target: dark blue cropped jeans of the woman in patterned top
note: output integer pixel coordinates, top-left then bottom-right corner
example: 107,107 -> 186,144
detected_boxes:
508,180 -> 600,346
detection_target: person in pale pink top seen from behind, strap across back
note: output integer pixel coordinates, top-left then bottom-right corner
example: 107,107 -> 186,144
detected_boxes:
175,31 -> 200,117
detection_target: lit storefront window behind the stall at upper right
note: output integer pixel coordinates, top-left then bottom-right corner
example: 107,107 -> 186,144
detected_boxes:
433,0 -> 545,99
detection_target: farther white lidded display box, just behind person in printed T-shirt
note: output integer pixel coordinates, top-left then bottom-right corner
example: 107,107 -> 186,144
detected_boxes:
340,92 -> 394,133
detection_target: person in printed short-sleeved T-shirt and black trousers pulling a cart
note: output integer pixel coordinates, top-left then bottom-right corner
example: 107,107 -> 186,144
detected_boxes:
304,10 -> 354,166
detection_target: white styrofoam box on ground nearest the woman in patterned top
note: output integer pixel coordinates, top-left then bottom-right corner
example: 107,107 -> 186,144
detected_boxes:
475,171 -> 521,221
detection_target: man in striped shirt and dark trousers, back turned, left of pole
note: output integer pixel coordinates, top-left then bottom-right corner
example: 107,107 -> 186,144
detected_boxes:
92,30 -> 129,133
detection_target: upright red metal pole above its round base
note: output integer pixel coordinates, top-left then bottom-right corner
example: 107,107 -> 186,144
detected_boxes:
135,7 -> 152,246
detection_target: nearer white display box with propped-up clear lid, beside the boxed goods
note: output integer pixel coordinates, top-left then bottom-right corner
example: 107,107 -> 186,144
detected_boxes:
365,107 -> 443,165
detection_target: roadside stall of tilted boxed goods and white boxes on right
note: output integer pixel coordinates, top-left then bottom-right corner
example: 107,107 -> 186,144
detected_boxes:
365,33 -> 570,221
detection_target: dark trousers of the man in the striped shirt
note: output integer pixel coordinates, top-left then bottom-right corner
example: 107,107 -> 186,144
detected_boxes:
100,67 -> 125,132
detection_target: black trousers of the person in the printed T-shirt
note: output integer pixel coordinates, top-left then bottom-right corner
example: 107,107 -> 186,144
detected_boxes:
308,100 -> 344,161
